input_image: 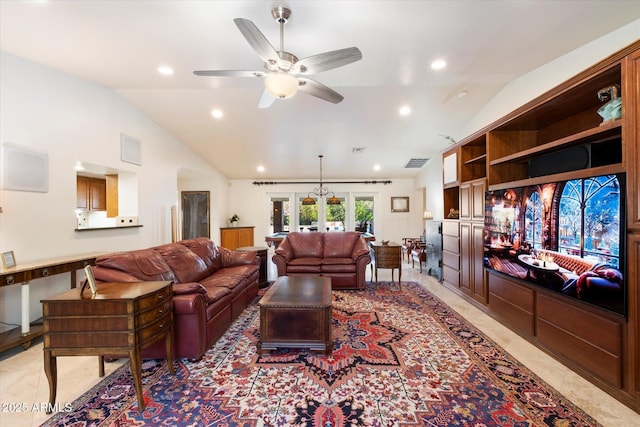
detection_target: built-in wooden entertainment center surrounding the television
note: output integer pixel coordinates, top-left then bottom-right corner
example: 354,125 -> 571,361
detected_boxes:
443,42 -> 640,412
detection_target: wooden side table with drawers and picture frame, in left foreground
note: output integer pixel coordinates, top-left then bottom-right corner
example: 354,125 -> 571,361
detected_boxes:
42,282 -> 175,411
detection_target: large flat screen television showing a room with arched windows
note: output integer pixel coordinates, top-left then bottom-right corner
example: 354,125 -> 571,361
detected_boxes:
484,174 -> 626,315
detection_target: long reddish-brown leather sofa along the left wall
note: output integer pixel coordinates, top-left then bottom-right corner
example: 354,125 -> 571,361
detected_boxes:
93,237 -> 260,360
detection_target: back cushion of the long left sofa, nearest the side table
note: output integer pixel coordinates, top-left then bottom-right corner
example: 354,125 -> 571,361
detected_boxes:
96,249 -> 176,281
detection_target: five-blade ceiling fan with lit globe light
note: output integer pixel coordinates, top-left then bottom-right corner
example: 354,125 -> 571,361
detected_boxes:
193,6 -> 362,108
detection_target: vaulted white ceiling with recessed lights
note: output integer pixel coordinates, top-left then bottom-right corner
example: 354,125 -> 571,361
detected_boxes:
0,0 -> 640,179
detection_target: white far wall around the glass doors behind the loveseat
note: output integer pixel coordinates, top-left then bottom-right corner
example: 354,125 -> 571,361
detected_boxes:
228,179 -> 424,246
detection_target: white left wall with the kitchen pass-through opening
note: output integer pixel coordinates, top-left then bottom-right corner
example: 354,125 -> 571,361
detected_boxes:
0,52 -> 228,323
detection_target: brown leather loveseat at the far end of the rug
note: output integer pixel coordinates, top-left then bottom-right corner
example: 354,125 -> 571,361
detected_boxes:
272,231 -> 371,289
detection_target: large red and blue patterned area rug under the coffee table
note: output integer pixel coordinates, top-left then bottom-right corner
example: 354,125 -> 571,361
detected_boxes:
43,282 -> 598,427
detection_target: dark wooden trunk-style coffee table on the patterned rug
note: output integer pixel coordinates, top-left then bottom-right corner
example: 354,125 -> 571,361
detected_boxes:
257,276 -> 333,354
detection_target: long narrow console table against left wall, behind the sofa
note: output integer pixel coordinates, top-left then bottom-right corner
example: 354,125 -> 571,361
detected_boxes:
0,253 -> 103,353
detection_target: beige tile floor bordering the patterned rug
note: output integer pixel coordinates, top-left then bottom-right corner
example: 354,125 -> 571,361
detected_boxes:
0,256 -> 640,427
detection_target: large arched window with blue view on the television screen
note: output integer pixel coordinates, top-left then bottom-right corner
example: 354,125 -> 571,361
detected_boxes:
558,175 -> 620,266
